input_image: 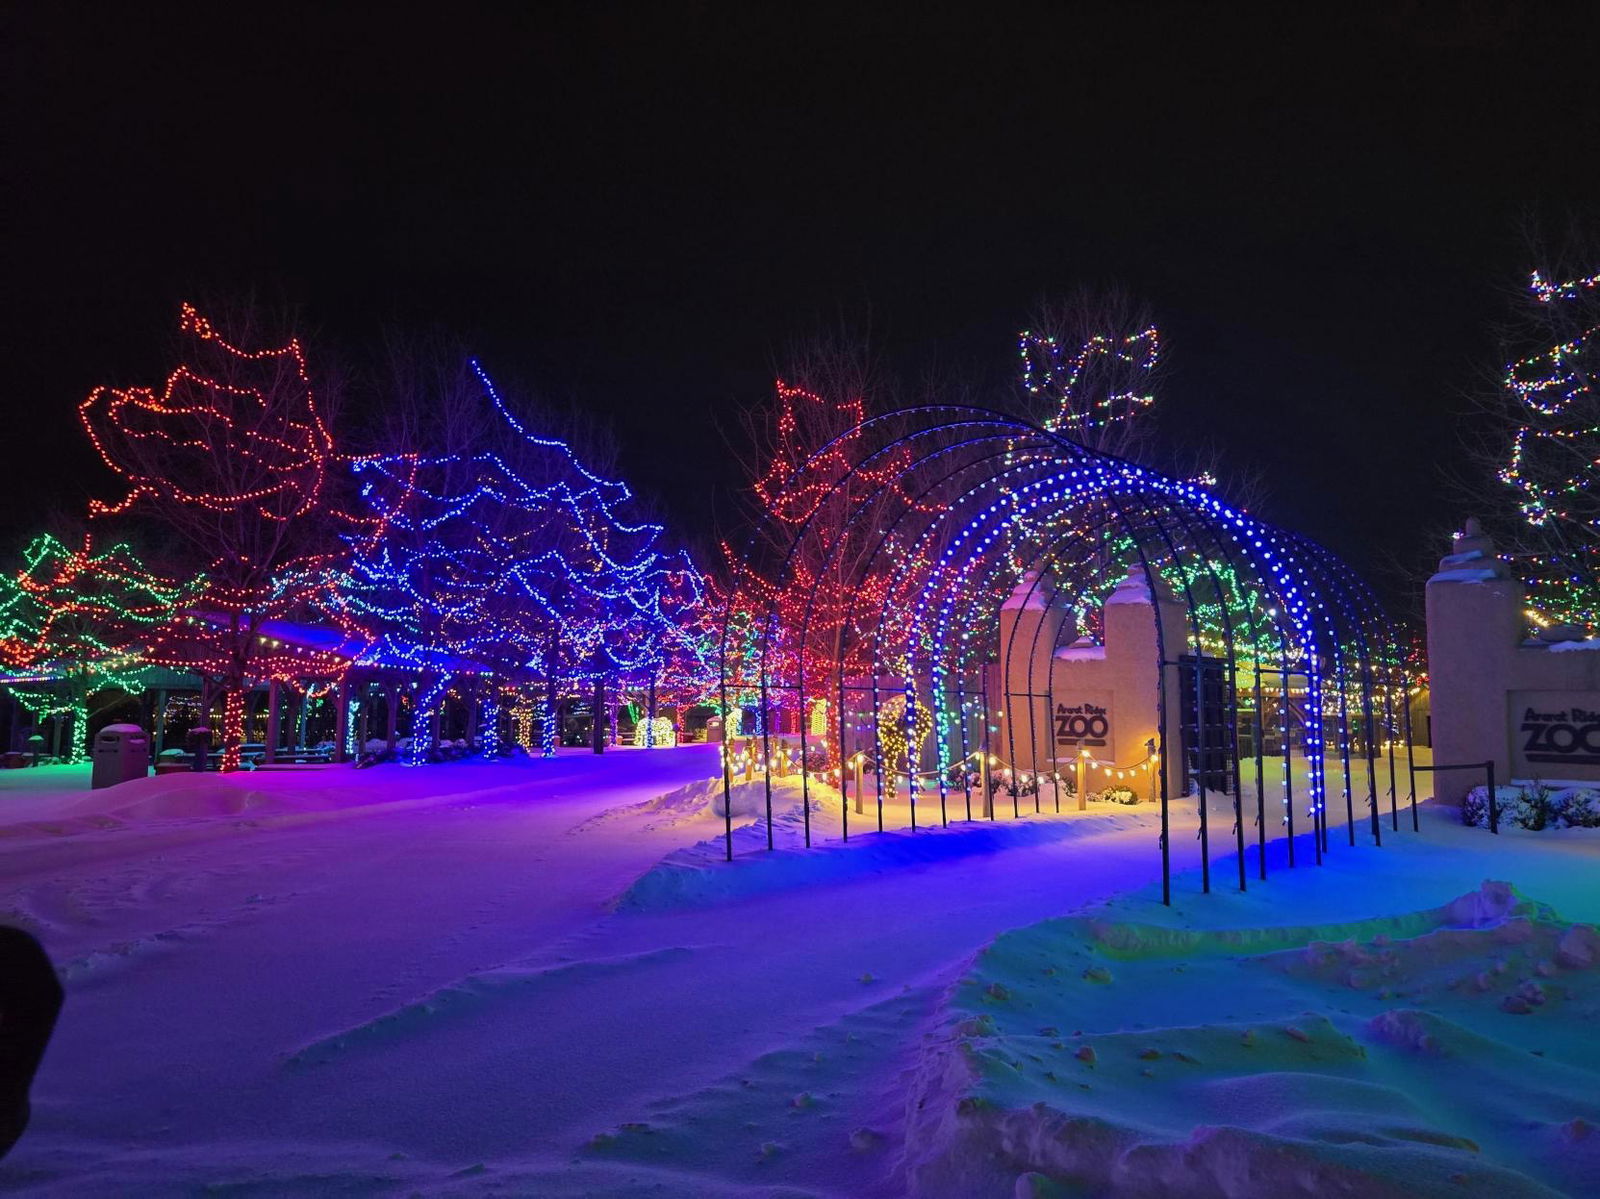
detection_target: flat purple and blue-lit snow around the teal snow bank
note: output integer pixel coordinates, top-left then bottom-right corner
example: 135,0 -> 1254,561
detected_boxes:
0,748 -> 1600,1196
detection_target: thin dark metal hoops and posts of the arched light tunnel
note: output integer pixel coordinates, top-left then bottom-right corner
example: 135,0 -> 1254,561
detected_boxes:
720,405 -> 1414,898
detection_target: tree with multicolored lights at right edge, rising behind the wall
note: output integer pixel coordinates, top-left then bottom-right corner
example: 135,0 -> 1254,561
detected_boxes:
1501,272 -> 1600,628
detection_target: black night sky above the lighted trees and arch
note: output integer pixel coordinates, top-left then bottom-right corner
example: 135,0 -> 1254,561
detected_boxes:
0,3 -> 1600,617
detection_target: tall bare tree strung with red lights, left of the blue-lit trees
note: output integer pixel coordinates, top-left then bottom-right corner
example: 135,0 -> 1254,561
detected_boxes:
78,304 -> 345,770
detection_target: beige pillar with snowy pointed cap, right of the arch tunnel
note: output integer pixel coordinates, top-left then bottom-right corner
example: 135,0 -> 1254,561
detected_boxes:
1418,520 -> 1526,804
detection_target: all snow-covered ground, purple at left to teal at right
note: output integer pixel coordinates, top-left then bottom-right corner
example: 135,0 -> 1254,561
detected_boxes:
0,746 -> 1600,1196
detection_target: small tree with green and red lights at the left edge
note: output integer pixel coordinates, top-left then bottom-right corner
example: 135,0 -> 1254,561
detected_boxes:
0,533 -> 202,762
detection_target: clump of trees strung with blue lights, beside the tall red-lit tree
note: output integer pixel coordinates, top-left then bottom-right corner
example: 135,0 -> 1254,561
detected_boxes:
325,362 -> 704,760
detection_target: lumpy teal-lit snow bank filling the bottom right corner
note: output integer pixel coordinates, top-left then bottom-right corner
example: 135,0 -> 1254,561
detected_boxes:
907,882 -> 1600,1197
